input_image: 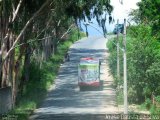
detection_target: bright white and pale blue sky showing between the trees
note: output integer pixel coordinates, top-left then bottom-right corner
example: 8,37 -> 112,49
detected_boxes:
82,0 -> 141,36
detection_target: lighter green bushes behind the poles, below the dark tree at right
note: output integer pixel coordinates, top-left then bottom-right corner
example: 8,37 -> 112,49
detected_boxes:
107,25 -> 160,103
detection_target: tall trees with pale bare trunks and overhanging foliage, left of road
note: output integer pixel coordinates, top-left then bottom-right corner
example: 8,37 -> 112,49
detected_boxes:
0,0 -> 113,107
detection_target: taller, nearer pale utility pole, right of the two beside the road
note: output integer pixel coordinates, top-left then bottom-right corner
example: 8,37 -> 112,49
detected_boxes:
123,19 -> 128,114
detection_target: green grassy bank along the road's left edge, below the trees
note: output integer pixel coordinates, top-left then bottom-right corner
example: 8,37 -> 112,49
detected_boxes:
10,27 -> 85,120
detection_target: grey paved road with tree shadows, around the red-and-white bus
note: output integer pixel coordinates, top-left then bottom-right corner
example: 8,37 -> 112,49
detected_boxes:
31,37 -> 118,120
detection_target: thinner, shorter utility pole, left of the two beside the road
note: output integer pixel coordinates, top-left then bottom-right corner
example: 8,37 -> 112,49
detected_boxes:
117,19 -> 120,80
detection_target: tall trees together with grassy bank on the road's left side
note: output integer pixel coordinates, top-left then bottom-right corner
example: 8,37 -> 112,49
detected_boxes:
0,0 -> 113,117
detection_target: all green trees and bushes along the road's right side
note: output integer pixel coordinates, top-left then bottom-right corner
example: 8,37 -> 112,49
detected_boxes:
107,0 -> 160,114
